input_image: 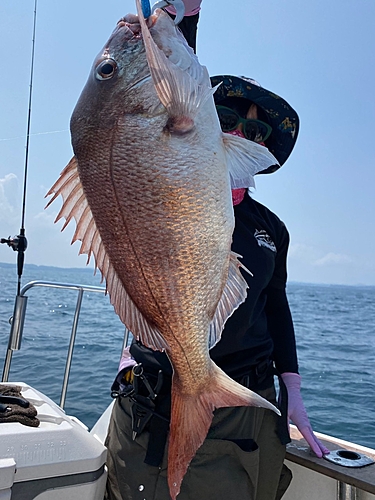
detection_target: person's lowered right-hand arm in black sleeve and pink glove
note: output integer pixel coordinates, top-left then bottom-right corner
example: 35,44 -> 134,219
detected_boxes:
266,227 -> 329,457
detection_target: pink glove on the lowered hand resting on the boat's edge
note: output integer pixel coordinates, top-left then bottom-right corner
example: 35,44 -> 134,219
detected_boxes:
281,373 -> 329,458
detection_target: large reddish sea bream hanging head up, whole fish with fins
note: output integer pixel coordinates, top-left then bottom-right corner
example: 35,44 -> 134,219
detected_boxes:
48,0 -> 277,499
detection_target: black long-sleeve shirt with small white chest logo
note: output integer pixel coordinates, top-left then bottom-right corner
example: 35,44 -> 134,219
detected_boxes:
210,194 -> 298,378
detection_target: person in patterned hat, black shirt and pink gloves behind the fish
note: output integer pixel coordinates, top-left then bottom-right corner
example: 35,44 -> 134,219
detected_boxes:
100,1 -> 329,500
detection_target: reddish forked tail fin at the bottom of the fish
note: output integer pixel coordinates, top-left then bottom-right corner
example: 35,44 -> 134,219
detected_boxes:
168,363 -> 280,500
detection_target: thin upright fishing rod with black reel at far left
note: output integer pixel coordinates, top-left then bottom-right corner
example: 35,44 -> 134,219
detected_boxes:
0,0 -> 37,296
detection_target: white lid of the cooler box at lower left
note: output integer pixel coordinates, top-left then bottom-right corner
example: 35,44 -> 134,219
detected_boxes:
0,382 -> 107,483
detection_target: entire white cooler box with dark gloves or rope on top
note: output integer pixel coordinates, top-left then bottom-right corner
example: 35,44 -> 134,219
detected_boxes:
0,382 -> 107,500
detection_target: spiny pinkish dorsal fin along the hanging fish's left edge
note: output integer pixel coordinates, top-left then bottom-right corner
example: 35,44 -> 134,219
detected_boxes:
46,156 -> 167,351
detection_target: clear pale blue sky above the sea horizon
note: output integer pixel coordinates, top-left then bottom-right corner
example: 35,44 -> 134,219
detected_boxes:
0,0 -> 375,285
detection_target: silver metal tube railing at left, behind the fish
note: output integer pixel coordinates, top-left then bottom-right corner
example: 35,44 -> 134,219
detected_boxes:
2,281 -> 129,408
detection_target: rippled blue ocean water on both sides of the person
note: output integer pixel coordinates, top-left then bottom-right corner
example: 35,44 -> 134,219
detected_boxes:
0,263 -> 375,448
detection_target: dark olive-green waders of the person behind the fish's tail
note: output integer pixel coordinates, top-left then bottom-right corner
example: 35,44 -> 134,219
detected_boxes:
105,387 -> 291,500
